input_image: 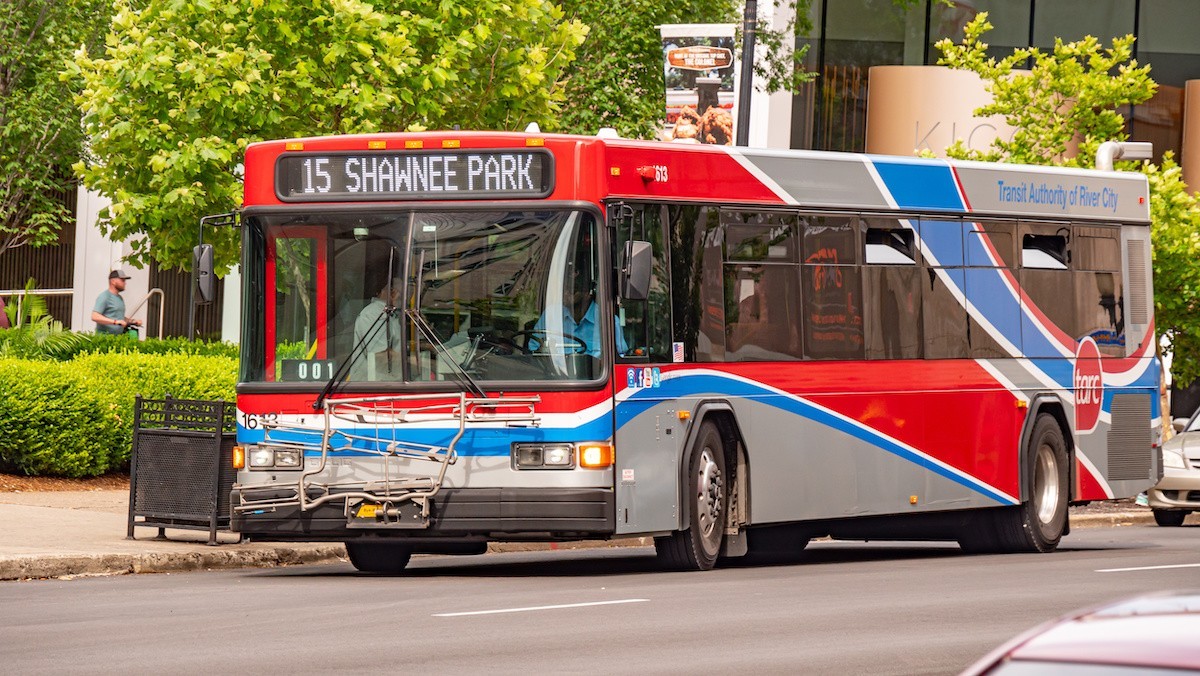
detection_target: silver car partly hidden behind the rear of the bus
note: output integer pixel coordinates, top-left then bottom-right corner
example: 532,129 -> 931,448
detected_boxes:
1146,409 -> 1200,526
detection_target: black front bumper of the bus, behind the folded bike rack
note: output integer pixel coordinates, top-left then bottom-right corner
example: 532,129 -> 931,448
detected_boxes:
230,487 -> 616,542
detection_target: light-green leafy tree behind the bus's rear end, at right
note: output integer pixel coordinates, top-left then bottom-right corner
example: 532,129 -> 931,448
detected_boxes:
937,12 -> 1200,383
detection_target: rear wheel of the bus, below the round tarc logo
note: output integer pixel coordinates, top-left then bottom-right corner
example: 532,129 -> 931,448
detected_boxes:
995,413 -> 1068,552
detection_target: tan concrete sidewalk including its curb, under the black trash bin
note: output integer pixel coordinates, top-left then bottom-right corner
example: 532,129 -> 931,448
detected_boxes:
0,490 -> 1154,580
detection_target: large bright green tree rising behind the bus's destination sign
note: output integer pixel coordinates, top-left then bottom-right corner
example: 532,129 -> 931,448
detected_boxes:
66,0 -> 587,268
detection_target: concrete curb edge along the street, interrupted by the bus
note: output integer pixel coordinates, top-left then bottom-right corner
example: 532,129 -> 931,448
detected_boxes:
0,509 -> 1154,581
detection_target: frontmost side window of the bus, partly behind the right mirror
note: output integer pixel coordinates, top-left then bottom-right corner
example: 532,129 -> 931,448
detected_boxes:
613,204 -> 671,361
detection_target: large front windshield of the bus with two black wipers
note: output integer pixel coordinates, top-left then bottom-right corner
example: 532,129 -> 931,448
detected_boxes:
256,210 -> 605,384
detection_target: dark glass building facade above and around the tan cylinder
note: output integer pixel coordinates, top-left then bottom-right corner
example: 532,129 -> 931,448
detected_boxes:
791,0 -> 1200,168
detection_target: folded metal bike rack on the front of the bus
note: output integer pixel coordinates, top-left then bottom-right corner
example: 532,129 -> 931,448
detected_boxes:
234,393 -> 541,528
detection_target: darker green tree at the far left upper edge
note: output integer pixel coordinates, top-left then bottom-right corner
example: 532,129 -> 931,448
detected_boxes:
0,0 -> 108,256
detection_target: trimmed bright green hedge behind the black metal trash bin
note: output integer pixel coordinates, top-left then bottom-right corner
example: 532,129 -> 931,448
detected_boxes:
0,353 -> 238,477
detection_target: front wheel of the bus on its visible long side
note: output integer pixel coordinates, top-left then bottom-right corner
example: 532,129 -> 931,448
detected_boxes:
654,420 -> 728,570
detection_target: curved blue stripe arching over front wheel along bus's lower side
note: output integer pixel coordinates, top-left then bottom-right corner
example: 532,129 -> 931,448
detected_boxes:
617,373 -> 1016,504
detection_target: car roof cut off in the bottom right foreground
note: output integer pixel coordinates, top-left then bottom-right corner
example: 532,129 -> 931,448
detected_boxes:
962,592 -> 1200,676
